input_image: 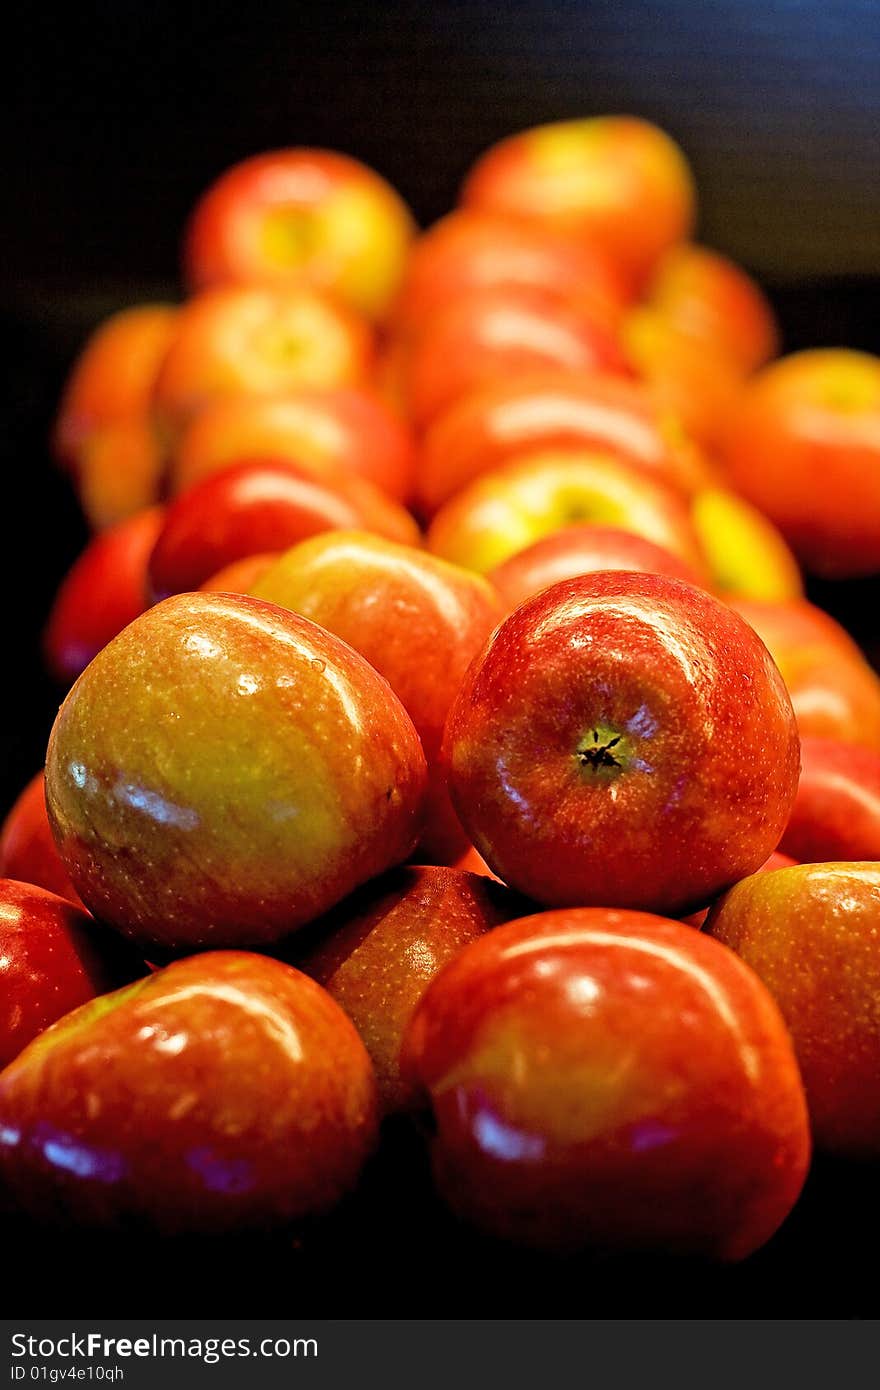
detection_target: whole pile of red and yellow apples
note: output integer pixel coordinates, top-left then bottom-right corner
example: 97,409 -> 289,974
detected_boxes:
0,117 -> 880,1259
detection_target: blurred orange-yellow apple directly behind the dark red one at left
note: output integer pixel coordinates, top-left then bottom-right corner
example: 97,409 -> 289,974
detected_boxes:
170,386 -> 413,502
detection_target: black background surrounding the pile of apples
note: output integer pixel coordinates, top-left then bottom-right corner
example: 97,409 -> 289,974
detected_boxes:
0,0 -> 880,1316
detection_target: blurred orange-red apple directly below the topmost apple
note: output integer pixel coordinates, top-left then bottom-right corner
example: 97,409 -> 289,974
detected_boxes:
393,207 -> 628,336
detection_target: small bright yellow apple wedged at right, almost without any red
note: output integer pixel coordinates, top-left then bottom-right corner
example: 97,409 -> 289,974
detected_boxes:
691,488 -> 804,603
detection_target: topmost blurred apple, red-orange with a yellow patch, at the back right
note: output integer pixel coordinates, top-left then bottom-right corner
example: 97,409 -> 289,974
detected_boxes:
462,115 -> 696,285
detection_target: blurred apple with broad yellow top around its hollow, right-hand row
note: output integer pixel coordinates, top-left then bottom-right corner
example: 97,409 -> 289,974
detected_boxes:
427,449 -> 708,578
